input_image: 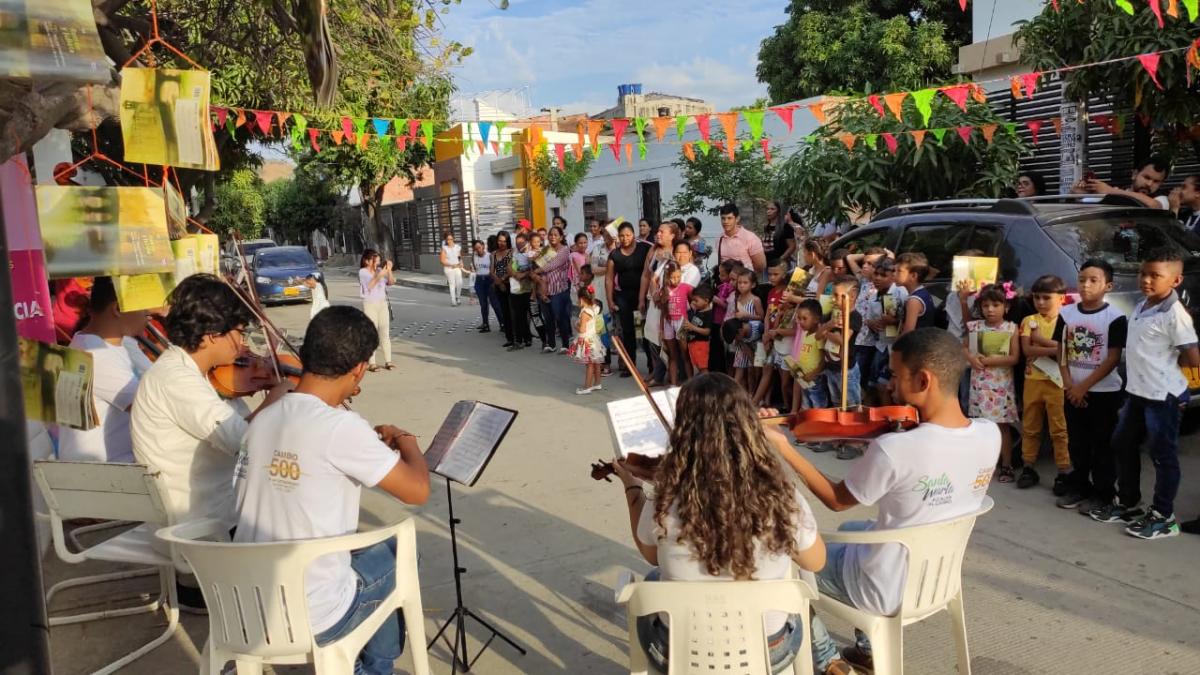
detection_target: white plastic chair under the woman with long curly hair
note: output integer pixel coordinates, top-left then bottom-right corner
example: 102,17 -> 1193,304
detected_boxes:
617,572 -> 817,675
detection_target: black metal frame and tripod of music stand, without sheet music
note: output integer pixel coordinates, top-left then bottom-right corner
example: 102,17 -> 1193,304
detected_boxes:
426,401 -> 526,675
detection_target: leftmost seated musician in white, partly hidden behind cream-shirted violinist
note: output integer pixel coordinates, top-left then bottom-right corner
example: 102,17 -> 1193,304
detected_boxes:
59,276 -> 150,462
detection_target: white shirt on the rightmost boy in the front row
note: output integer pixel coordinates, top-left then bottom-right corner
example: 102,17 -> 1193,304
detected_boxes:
1126,291 -> 1196,401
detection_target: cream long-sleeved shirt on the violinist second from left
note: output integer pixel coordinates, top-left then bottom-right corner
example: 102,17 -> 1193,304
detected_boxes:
130,346 -> 248,527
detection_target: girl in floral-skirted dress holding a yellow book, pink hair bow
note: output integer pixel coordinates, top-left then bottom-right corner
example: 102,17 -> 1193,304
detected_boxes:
962,283 -> 1021,483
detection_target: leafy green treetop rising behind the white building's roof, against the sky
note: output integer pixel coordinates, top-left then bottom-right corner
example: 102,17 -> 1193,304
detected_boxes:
757,0 -> 971,103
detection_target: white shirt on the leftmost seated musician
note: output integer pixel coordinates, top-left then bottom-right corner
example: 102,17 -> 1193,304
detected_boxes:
59,333 -> 139,462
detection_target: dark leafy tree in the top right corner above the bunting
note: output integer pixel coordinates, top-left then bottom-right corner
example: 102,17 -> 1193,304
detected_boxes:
1015,2 -> 1200,160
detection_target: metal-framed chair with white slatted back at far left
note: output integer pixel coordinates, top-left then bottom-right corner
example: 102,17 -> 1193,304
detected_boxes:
34,460 -> 179,675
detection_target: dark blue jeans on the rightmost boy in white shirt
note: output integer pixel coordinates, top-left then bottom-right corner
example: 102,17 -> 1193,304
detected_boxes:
1112,394 -> 1182,518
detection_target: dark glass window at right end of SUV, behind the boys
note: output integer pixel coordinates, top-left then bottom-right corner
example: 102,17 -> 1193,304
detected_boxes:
1046,214 -> 1200,274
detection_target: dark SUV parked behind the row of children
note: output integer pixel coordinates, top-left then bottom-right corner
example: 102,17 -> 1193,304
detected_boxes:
833,196 -> 1200,405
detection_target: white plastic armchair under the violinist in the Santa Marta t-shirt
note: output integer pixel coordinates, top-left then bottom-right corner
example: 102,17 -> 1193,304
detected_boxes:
815,497 -> 994,675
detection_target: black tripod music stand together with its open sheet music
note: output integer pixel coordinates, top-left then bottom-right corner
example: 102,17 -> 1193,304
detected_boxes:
426,401 -> 526,675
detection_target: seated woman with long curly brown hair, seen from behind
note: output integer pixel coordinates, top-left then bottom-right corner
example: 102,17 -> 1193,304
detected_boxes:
614,372 -> 826,673
